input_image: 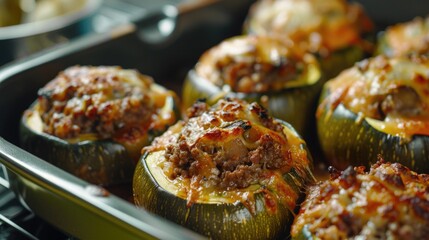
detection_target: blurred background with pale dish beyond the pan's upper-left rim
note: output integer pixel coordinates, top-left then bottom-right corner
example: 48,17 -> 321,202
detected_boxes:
0,0 -> 192,66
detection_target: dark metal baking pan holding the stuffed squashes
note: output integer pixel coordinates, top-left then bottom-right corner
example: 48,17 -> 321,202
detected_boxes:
0,0 -> 428,239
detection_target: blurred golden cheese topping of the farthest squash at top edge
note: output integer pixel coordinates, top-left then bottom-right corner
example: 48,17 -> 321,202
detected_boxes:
247,0 -> 373,54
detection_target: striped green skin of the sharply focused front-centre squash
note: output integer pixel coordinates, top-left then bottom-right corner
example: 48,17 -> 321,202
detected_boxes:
133,119 -> 315,239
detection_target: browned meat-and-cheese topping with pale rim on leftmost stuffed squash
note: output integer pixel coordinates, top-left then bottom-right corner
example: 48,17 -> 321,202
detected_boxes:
26,66 -> 176,152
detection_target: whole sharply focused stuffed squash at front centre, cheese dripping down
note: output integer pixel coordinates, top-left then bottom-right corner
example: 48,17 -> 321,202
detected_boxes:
133,100 -> 314,239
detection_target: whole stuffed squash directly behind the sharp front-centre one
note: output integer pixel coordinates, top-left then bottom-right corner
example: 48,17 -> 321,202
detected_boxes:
182,36 -> 321,134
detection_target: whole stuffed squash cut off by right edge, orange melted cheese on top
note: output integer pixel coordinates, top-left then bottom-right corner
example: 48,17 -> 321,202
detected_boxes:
317,56 -> 429,173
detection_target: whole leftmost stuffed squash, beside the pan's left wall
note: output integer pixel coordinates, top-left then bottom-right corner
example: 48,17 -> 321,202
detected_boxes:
20,66 -> 178,185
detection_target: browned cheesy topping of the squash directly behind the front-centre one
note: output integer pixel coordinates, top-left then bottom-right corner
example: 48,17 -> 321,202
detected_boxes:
195,36 -> 320,93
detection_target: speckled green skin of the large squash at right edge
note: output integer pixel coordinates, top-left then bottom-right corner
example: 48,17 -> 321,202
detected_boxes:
317,104 -> 429,173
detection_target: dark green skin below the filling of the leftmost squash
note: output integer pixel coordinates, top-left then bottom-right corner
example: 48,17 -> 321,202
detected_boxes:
20,112 -> 135,186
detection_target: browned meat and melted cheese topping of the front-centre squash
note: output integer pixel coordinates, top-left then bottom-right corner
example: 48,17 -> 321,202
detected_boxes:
144,100 -> 312,212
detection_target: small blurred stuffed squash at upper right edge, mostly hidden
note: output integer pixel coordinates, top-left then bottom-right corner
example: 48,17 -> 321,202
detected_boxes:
376,16 -> 429,57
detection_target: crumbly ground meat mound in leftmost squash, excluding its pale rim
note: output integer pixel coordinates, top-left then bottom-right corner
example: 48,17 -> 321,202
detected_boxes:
38,66 -> 154,139
